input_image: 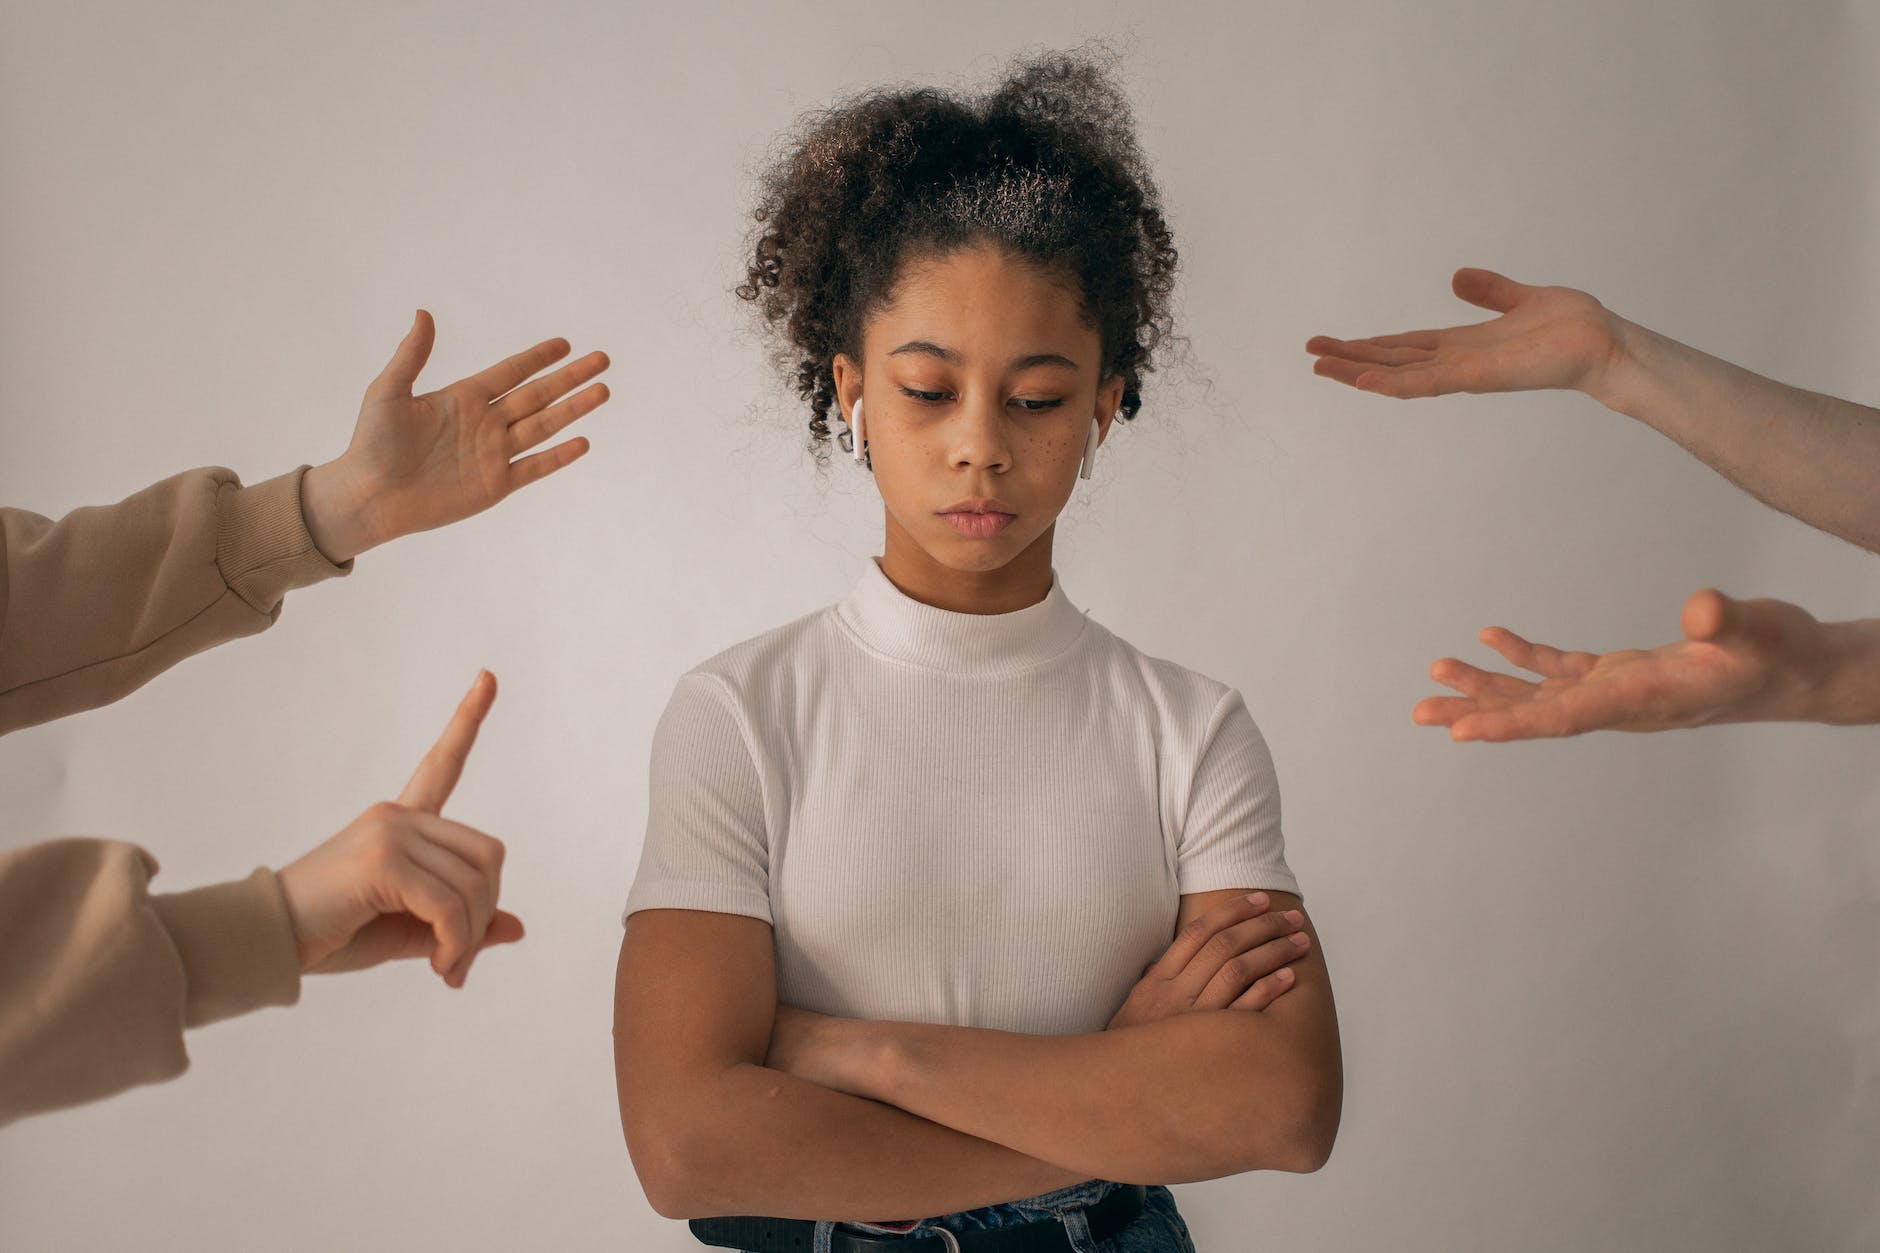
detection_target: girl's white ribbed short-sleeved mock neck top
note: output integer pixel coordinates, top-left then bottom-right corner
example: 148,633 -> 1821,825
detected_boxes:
626,563 -> 1299,1033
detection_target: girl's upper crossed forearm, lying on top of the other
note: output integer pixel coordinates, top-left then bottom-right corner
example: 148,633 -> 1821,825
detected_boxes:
833,993 -> 1342,1183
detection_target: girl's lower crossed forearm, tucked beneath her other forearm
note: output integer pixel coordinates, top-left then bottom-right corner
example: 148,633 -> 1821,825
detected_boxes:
635,1065 -> 1090,1221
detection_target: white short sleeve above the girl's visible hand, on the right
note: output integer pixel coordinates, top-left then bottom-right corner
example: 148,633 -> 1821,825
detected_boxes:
1175,690 -> 1299,896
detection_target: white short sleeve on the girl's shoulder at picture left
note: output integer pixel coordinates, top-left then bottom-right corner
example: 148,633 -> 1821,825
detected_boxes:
626,674 -> 771,922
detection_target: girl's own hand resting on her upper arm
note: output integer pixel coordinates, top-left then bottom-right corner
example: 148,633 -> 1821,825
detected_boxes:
1109,892 -> 1312,1027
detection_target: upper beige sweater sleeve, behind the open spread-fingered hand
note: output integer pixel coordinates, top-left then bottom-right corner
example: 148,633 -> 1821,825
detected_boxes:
0,467 -> 352,734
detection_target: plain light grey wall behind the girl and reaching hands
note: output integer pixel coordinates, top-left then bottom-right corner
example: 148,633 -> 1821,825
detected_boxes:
0,0 -> 1880,1251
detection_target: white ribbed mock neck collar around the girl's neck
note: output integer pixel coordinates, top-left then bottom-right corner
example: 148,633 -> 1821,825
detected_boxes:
835,559 -> 1085,677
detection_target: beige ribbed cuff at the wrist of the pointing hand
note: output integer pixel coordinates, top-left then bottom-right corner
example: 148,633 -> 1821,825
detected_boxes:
150,867 -> 301,1027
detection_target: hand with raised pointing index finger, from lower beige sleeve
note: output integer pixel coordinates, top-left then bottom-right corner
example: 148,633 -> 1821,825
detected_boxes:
280,672 -> 523,988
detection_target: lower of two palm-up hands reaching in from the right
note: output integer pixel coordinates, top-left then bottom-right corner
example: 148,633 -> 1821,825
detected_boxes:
1410,589 -> 1824,741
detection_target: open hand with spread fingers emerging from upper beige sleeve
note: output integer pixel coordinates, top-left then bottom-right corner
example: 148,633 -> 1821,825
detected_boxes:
301,310 -> 607,563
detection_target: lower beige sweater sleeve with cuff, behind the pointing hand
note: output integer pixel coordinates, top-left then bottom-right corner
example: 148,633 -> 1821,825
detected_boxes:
0,839 -> 301,1125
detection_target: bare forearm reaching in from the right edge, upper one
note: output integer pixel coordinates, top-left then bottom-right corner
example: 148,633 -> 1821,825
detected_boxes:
1590,318 -> 1880,551
